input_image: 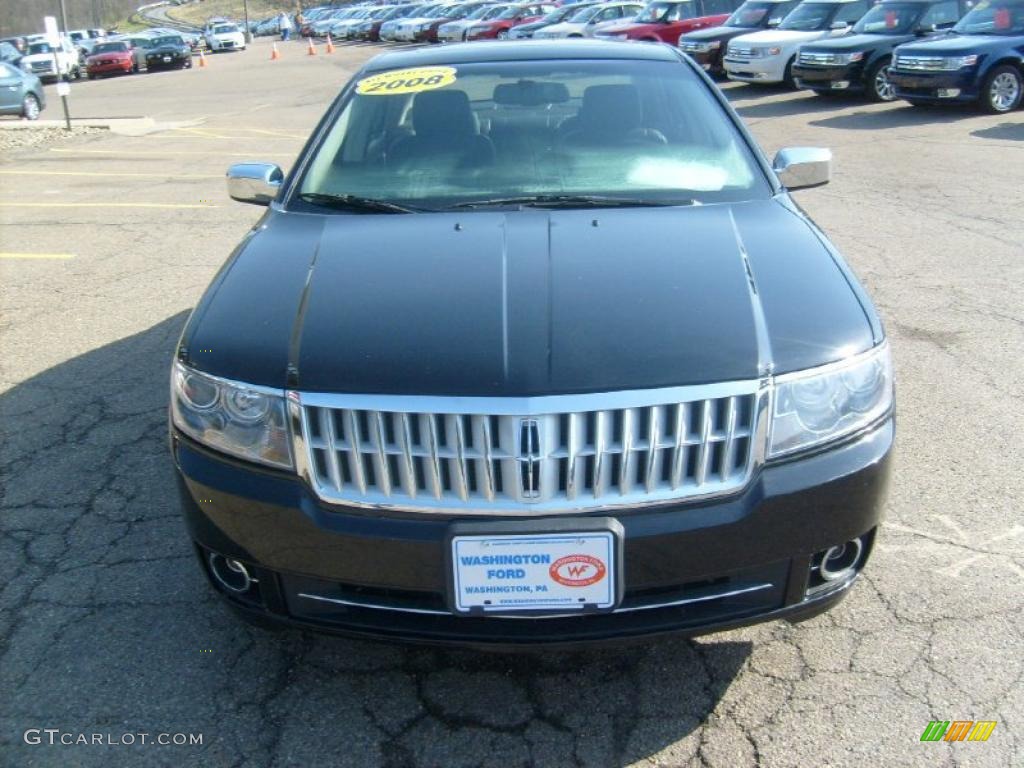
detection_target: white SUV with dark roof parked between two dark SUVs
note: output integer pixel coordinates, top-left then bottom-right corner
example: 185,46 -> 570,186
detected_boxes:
723,0 -> 872,85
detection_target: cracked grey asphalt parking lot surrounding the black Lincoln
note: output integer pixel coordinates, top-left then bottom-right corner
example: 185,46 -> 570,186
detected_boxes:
0,34 -> 1024,768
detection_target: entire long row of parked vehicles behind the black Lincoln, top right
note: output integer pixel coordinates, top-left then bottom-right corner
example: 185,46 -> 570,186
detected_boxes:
300,0 -> 1024,113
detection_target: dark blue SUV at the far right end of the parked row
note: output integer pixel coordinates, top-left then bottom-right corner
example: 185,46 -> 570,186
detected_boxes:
889,0 -> 1024,114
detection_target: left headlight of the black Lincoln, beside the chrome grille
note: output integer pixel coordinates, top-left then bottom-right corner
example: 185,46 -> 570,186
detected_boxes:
171,362 -> 294,469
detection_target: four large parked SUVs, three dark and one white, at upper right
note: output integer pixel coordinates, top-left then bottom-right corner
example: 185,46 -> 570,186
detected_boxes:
679,0 -> 1024,113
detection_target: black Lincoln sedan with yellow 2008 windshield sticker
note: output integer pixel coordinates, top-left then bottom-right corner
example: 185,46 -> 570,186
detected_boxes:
170,40 -> 894,647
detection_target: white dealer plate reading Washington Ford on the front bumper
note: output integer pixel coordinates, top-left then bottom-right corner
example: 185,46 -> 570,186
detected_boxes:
452,530 -> 616,612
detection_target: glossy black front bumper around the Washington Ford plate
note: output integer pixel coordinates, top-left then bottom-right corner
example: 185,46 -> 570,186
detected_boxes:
172,420 -> 894,647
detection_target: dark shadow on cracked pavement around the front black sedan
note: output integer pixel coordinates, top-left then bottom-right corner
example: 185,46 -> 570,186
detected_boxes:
0,312 -> 752,768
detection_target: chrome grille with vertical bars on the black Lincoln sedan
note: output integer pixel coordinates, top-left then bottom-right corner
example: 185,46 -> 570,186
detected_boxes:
289,382 -> 767,515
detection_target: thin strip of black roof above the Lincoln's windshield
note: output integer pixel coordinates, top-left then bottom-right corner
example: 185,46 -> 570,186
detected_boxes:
364,40 -> 679,72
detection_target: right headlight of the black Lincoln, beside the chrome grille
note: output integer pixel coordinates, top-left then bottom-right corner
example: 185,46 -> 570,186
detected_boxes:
768,343 -> 893,459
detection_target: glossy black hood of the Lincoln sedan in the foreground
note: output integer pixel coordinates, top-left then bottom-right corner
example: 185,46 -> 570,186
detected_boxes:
182,198 -> 874,396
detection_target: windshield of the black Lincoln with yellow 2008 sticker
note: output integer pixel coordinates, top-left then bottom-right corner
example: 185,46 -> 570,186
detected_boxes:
297,59 -> 771,210
